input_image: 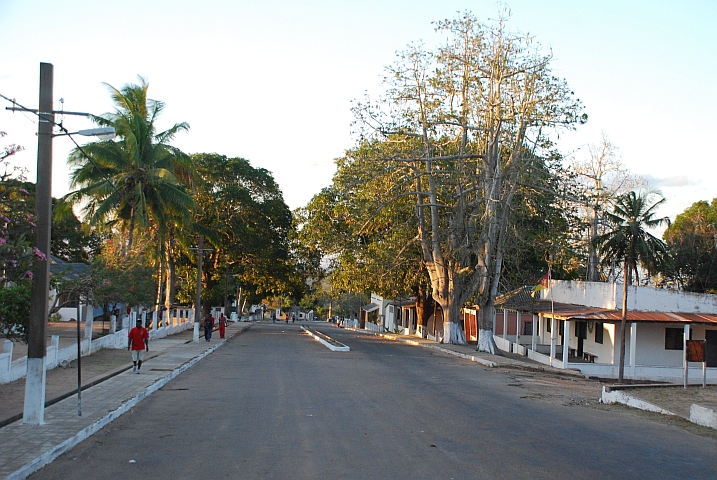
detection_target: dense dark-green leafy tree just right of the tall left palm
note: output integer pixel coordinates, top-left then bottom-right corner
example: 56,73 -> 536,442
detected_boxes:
183,153 -> 300,312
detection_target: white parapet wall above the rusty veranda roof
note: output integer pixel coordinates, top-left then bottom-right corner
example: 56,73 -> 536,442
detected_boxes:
542,280 -> 717,314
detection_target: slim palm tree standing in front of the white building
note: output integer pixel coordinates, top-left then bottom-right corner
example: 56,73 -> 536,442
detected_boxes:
593,191 -> 670,383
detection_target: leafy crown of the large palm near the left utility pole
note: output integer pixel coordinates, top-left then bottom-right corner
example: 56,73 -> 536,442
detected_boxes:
63,77 -> 196,251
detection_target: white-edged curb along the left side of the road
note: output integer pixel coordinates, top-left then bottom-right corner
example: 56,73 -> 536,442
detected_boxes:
6,324 -> 251,480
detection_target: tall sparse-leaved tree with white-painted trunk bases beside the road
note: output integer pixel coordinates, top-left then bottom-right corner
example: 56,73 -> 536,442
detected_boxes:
342,12 -> 586,351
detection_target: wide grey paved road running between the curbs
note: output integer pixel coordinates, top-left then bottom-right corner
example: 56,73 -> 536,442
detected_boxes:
32,324 -> 717,480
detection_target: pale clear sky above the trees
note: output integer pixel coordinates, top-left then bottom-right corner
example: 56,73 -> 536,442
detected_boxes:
0,0 -> 717,225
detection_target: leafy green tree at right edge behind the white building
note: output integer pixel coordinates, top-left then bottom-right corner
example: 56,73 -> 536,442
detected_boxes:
662,198 -> 717,294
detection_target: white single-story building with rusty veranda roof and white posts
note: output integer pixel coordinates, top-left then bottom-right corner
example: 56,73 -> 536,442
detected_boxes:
494,280 -> 717,383
